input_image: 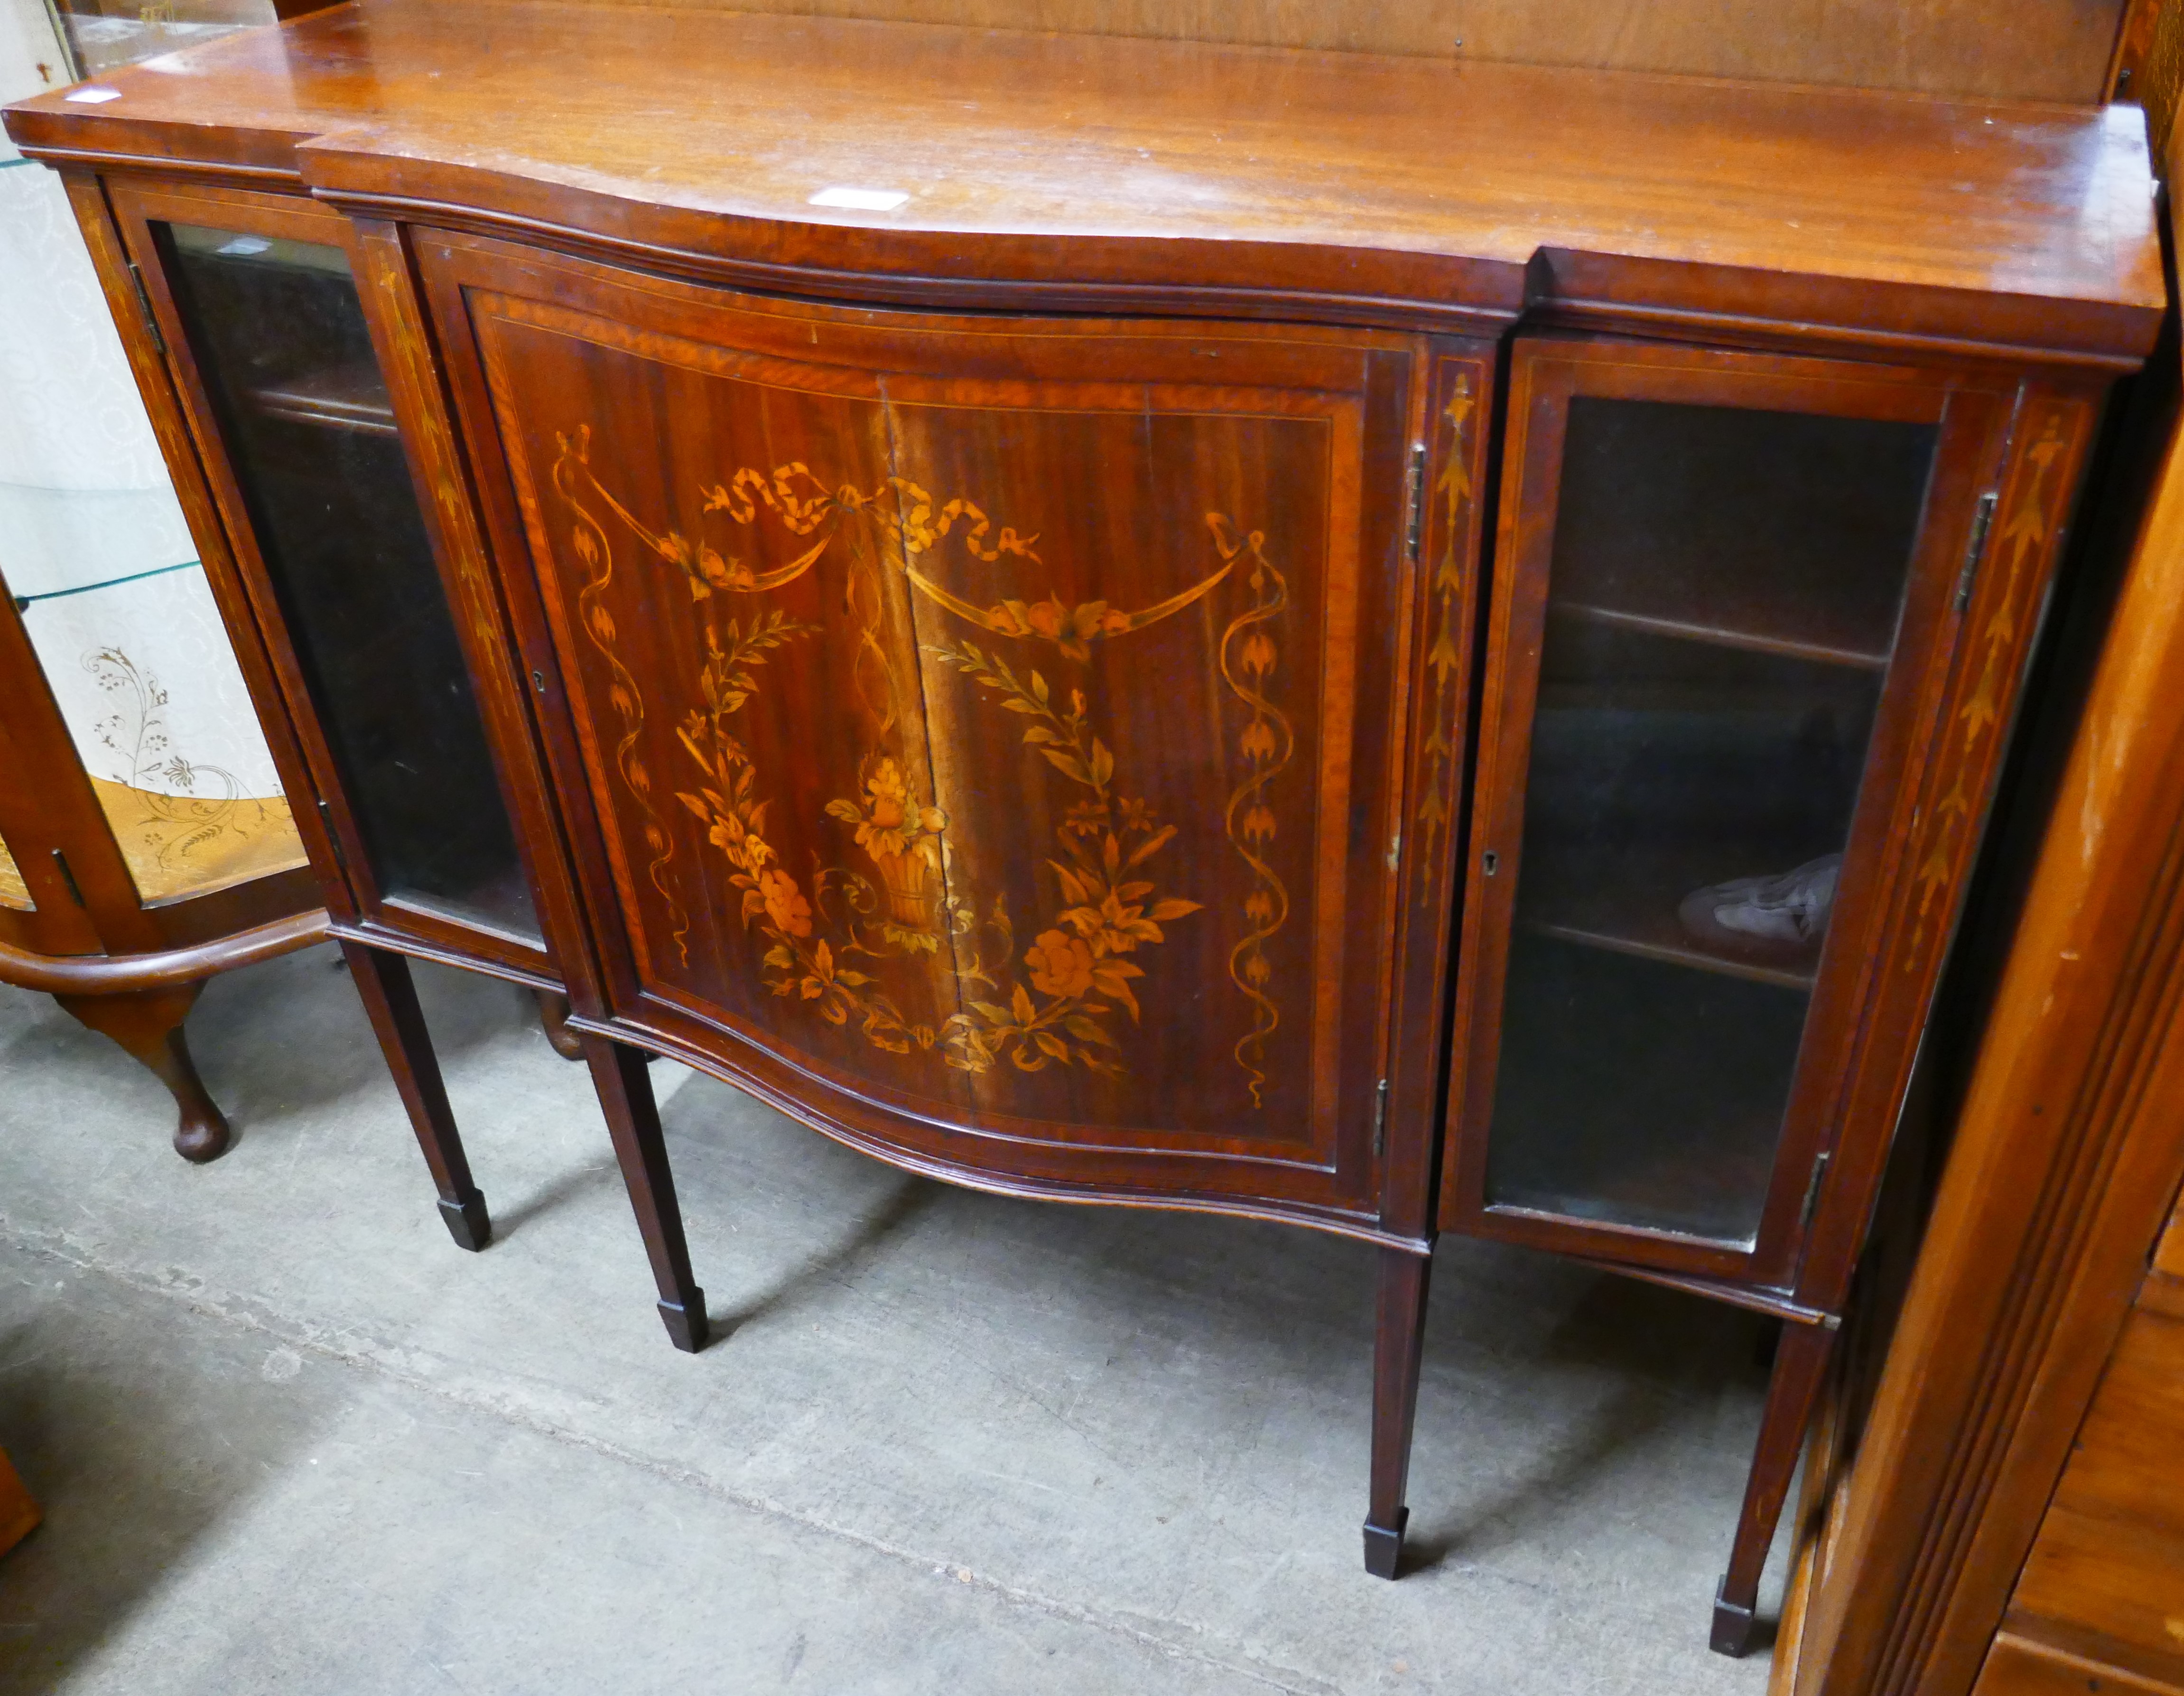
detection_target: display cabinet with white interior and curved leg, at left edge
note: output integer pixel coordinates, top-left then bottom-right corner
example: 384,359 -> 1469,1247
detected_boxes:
0,26 -> 325,1161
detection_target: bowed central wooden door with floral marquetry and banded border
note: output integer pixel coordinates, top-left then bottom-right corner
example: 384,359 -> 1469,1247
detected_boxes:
417,234 -> 1483,1235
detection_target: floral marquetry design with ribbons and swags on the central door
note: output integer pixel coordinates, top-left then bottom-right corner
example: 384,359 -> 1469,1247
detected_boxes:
553,429 -> 1295,1088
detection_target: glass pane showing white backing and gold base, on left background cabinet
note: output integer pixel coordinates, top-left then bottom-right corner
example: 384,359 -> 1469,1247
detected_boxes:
0,170 -> 306,905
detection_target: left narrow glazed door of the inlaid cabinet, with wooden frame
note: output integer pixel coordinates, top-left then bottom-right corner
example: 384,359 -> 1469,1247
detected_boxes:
109,179 -> 557,984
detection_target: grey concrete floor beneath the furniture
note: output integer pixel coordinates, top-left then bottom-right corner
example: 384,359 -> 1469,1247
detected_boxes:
0,949 -> 1782,1696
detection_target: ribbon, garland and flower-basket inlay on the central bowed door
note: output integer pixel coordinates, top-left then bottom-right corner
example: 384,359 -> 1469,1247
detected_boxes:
553,429 -> 1295,1088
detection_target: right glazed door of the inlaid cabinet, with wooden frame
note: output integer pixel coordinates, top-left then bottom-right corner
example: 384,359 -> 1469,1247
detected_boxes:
1441,339 -> 2090,1303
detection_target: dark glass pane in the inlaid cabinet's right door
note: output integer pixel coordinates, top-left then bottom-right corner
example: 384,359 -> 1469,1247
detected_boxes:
1487,398 -> 1937,1244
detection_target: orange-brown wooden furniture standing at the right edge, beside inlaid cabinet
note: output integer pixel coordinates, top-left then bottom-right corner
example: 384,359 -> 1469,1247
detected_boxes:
1775,109 -> 2184,1696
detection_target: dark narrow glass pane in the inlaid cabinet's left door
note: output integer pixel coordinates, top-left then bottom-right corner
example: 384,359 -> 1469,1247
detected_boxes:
164,225 -> 537,940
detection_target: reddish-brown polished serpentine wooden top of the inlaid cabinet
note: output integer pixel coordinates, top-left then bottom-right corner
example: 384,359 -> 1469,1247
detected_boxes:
9,0 -> 2165,367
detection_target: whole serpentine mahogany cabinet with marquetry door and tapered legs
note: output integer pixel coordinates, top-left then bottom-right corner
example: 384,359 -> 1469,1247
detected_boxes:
9,0 -> 2162,1652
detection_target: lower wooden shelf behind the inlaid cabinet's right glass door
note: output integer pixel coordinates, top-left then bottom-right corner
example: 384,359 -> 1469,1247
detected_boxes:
1518,841 -> 1822,990
